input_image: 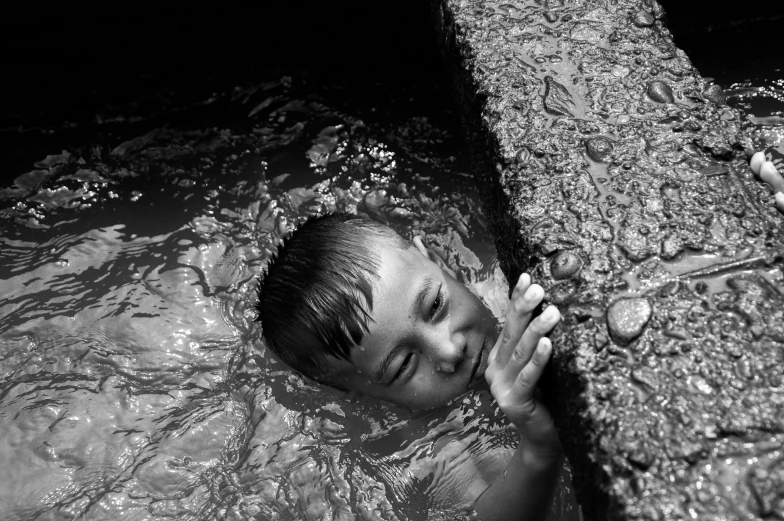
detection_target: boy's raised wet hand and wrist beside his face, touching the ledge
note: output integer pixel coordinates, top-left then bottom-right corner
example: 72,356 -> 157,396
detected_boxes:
485,273 -> 561,456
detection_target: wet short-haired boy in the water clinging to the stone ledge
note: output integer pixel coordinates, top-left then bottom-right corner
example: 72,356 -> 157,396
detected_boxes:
258,154 -> 784,521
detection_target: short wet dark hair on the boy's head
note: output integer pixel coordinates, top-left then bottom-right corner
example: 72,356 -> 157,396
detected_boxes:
256,213 -> 411,385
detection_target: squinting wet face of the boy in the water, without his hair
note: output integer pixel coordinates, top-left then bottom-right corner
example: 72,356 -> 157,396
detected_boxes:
331,239 -> 498,409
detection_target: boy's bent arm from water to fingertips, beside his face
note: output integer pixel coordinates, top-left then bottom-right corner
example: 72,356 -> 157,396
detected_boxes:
474,274 -> 562,521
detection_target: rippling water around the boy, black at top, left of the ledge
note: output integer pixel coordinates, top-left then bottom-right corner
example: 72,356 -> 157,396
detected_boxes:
0,1 -> 780,520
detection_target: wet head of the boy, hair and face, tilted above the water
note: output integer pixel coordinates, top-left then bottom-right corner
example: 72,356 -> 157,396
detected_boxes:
257,214 -> 498,409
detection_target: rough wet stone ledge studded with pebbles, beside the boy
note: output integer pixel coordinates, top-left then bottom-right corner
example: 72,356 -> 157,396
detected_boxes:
433,0 -> 784,520
